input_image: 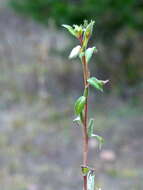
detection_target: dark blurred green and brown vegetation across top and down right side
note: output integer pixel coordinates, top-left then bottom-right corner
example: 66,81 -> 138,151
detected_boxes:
10,0 -> 143,97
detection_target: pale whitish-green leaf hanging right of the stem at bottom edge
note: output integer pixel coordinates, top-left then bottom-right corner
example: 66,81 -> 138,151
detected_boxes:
87,171 -> 95,190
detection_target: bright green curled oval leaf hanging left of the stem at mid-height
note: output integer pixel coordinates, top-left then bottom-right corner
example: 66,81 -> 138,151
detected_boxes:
75,96 -> 86,115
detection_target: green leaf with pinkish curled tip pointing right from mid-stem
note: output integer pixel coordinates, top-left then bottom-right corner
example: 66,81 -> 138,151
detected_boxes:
87,77 -> 109,92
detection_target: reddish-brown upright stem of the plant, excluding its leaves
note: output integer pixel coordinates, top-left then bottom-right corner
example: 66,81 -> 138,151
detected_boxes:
82,56 -> 88,190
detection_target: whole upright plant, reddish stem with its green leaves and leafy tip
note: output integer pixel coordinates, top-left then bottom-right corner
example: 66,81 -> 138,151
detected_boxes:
62,20 -> 98,190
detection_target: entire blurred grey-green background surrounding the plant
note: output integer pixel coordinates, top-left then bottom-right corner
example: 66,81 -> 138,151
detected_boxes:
0,0 -> 143,190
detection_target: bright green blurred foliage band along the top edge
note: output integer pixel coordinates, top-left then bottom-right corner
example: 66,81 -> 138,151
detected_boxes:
10,0 -> 143,35
